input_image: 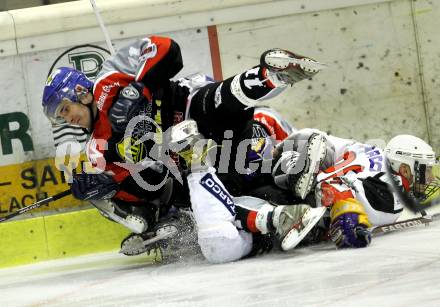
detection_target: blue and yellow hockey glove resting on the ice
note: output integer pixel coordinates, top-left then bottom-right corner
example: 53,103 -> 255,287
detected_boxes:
330,198 -> 371,248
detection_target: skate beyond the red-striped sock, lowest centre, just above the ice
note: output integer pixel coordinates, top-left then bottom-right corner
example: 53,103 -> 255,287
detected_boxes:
273,205 -> 326,251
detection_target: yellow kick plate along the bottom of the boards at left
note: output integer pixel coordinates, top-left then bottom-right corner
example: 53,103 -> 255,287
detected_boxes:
0,209 -> 129,267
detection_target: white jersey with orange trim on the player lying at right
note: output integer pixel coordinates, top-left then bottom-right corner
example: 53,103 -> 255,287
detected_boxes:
315,136 -> 403,226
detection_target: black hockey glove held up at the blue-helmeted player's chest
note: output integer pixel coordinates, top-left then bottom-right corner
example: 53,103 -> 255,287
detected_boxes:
108,82 -> 148,133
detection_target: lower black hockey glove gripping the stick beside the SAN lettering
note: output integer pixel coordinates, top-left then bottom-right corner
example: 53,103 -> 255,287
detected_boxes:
70,172 -> 119,200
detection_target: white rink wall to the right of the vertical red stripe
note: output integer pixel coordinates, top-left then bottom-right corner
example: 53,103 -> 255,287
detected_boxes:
218,0 -> 440,153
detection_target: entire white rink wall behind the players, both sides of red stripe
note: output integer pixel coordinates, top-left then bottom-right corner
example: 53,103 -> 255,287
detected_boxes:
0,0 -> 440,165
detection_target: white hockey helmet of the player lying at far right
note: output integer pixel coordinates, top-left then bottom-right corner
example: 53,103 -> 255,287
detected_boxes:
385,134 -> 436,197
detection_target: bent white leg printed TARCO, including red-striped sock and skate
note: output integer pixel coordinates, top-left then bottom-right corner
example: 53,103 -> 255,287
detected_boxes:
170,120 -> 325,263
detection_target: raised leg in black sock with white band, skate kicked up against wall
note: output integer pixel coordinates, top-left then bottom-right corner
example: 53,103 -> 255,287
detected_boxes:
189,49 -> 319,139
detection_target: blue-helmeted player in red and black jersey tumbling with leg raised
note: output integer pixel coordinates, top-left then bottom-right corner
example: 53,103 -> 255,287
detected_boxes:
43,36 -> 322,262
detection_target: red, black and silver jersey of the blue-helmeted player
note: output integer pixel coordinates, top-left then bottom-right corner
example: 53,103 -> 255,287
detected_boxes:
87,36 -> 184,201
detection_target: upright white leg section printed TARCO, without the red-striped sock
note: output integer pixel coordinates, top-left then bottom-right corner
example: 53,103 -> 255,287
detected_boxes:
170,120 -> 252,263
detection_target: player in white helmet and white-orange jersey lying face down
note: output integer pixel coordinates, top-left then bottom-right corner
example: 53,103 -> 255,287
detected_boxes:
273,129 -> 436,247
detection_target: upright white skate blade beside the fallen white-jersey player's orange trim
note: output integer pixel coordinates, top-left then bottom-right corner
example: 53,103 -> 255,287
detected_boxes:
294,133 -> 327,199
